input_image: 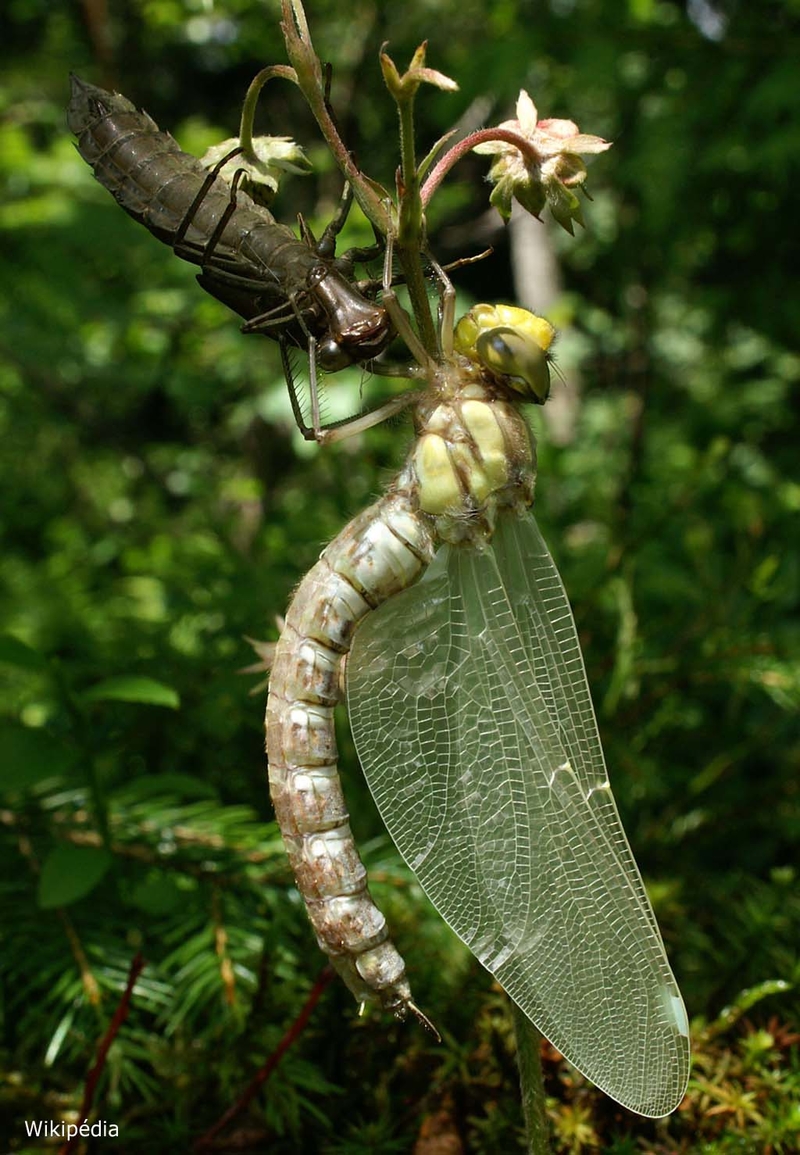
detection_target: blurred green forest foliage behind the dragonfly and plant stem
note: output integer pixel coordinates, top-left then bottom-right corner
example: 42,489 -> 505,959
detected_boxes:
0,0 -> 800,1155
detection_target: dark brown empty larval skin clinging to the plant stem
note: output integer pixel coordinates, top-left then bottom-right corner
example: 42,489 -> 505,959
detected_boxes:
67,75 -> 396,441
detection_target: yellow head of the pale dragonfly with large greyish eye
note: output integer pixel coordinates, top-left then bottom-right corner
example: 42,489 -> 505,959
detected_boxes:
455,305 -> 555,405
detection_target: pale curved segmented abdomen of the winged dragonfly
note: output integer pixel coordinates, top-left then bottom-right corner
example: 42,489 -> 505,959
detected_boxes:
267,493 -> 434,1018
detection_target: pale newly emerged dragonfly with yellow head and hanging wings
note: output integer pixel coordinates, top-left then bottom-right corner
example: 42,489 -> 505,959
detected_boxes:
266,238 -> 689,1118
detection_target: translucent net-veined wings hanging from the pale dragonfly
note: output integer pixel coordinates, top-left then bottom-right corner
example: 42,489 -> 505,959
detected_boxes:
347,515 -> 689,1117
